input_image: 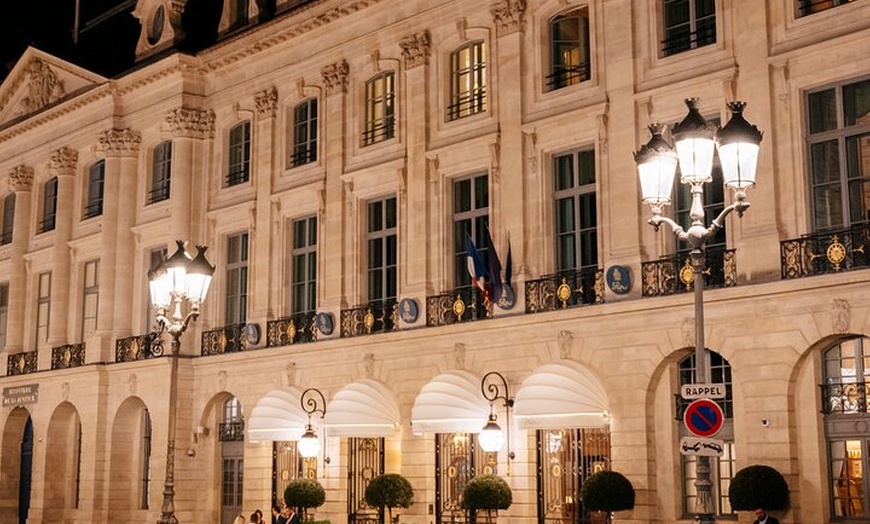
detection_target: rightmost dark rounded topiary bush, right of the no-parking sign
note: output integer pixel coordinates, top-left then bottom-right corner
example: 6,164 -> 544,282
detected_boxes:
728,464 -> 788,511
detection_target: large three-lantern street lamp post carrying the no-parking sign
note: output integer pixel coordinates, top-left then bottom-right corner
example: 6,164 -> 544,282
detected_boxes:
635,98 -> 762,524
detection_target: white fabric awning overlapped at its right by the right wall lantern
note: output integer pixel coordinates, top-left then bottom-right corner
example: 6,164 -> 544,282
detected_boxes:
411,370 -> 489,433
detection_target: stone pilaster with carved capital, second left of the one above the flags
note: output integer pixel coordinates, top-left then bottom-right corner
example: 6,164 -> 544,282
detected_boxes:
317,60 -> 355,319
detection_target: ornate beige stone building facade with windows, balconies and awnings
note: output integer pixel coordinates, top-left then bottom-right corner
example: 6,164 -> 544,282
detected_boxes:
0,0 -> 870,524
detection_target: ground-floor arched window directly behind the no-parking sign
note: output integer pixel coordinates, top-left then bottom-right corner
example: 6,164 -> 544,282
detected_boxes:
676,349 -> 736,516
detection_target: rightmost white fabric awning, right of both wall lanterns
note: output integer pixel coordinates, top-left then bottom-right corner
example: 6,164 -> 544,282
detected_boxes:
514,360 -> 610,429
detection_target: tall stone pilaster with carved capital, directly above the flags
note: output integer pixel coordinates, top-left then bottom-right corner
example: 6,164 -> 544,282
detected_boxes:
488,0 -> 528,314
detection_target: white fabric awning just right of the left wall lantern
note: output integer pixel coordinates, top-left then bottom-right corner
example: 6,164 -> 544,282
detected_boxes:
324,378 -> 401,437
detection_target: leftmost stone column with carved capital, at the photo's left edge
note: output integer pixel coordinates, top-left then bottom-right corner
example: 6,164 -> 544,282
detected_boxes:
3,165 -> 35,354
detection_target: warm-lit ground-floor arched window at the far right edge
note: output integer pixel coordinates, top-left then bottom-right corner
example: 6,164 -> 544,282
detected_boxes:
821,337 -> 870,518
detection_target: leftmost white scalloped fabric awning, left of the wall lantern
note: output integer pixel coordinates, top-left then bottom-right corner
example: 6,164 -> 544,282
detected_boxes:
245,387 -> 308,441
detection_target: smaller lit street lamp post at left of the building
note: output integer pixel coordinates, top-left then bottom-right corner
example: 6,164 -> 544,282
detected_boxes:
148,240 -> 214,524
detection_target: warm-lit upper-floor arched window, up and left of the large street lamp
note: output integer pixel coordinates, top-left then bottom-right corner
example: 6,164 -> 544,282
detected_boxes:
547,7 -> 591,90
